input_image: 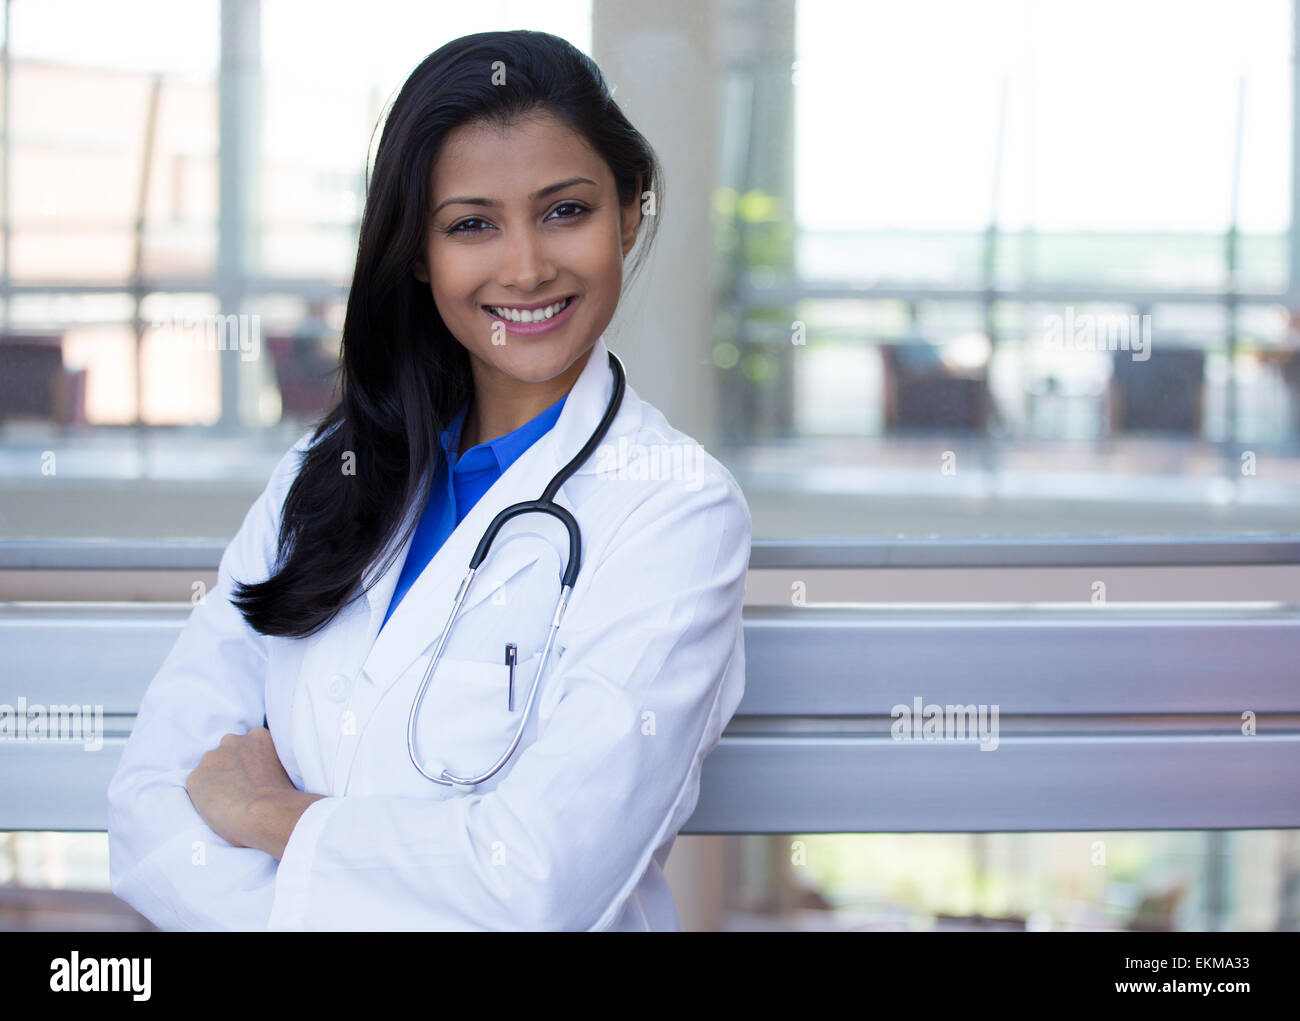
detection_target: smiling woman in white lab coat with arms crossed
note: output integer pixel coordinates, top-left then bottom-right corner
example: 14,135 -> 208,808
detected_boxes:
108,31 -> 750,930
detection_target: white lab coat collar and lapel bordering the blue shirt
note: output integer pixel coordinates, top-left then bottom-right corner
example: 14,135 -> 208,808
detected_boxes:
365,336 -> 641,688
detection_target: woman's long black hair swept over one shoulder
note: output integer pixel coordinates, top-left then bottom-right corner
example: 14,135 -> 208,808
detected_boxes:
231,31 -> 663,637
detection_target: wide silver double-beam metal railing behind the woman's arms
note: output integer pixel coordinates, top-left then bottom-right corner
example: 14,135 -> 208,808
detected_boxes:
0,603 -> 1300,832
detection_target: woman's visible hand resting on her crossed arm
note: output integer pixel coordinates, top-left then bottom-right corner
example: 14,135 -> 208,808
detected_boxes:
185,727 -> 298,847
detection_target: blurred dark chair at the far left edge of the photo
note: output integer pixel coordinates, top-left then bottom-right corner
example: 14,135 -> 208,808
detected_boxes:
0,333 -> 86,425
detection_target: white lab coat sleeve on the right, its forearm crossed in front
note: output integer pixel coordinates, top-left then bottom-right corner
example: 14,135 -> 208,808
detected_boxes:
269,465 -> 750,930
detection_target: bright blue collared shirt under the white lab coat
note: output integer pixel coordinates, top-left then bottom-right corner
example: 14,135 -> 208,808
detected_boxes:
380,394 -> 568,631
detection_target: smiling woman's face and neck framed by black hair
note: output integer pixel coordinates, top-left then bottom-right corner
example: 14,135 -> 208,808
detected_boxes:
412,114 -> 641,442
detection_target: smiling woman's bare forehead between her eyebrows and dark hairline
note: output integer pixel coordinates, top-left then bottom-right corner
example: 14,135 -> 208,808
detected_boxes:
429,114 -> 614,197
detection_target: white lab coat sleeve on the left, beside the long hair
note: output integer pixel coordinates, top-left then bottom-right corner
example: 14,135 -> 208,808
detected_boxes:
108,436 -> 308,931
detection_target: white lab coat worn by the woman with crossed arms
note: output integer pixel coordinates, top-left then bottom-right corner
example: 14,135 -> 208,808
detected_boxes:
108,338 -> 750,930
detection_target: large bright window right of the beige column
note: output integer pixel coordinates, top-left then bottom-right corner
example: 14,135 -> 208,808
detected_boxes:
719,0 -> 1300,540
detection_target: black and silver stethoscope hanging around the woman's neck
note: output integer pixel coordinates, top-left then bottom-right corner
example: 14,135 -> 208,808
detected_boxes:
407,351 -> 624,787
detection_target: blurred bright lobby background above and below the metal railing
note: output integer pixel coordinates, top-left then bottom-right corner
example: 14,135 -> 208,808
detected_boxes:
0,0 -> 1300,929
